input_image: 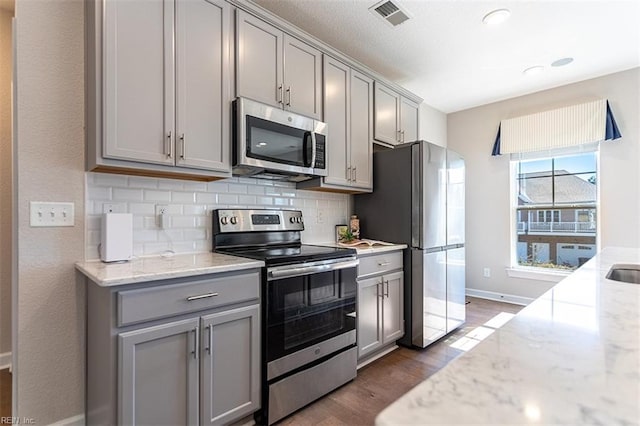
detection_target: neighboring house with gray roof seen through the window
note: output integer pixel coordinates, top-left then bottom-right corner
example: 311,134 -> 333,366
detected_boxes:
517,170 -> 596,268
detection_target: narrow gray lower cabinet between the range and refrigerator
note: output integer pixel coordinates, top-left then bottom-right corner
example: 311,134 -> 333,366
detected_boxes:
357,251 -> 404,361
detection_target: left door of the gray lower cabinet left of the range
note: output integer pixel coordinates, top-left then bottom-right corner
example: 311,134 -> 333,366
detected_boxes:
118,318 -> 199,425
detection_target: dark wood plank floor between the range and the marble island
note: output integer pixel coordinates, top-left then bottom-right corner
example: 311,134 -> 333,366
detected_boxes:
279,297 -> 522,426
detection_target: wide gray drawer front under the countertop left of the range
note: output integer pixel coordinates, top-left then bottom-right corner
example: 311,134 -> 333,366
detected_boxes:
117,272 -> 260,326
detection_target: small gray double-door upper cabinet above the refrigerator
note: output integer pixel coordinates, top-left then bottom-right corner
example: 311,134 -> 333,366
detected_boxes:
374,81 -> 418,145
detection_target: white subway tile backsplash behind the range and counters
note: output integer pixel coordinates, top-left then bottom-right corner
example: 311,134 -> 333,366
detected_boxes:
85,173 -> 349,259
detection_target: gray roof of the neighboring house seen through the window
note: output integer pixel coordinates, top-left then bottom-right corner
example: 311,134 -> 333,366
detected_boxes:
518,170 -> 596,205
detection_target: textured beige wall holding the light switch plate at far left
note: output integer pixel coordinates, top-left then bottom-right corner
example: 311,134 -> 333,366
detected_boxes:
13,0 -> 85,424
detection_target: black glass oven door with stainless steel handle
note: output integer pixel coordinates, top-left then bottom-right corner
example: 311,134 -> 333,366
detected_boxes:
265,259 -> 358,380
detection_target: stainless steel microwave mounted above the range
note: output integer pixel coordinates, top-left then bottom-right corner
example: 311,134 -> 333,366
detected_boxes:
233,98 -> 327,182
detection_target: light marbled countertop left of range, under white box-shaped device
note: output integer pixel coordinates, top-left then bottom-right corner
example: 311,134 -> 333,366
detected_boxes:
76,253 -> 264,287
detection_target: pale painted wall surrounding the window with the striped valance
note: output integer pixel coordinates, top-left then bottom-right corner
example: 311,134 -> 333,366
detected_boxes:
447,68 -> 640,298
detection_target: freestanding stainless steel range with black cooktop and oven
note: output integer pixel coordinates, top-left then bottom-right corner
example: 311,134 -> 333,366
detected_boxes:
213,210 -> 358,424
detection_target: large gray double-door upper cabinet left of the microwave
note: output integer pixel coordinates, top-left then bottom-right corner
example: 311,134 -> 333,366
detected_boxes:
87,0 -> 232,177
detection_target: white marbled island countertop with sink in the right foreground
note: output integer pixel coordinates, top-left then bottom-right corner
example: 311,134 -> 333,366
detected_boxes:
376,248 -> 640,425
